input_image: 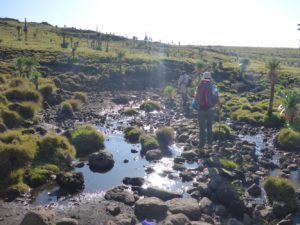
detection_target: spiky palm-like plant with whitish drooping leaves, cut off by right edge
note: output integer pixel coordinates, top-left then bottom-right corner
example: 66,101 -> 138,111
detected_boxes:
278,91 -> 300,123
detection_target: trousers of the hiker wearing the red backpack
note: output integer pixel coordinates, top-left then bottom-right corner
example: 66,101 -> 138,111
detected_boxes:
198,108 -> 215,148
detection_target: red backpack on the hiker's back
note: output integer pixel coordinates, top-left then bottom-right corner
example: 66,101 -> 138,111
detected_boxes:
196,79 -> 217,109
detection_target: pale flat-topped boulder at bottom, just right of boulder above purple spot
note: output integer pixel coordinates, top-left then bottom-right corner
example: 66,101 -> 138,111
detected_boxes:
166,198 -> 201,220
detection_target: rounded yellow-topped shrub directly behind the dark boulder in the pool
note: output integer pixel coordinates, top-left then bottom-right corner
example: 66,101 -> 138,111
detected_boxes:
71,125 -> 104,156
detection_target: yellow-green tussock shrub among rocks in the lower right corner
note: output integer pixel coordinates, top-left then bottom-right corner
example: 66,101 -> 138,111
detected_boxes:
264,176 -> 295,203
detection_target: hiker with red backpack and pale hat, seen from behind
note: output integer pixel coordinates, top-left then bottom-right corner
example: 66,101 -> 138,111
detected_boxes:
194,71 -> 220,150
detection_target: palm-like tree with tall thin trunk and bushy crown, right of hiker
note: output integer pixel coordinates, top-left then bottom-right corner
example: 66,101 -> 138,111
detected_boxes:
266,59 -> 280,116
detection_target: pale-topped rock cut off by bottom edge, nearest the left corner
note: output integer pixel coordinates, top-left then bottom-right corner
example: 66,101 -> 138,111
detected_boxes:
20,209 -> 54,225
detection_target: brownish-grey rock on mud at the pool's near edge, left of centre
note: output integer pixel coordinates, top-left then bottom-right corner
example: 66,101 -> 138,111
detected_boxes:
104,187 -> 135,205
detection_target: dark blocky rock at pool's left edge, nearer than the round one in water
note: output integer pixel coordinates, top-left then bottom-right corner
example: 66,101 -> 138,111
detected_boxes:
56,172 -> 84,193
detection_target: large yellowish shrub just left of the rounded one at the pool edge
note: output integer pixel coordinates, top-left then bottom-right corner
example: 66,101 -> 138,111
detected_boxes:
36,133 -> 75,169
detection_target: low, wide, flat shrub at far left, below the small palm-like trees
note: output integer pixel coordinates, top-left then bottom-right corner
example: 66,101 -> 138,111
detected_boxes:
5,88 -> 41,102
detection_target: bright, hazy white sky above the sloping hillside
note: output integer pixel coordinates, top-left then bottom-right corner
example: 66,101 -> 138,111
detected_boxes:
0,0 -> 300,48
